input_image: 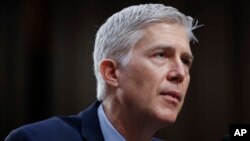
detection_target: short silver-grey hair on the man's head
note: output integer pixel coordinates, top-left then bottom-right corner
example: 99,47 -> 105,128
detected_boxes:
93,4 -> 198,101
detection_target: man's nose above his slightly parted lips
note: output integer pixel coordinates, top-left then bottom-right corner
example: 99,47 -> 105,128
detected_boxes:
167,61 -> 186,84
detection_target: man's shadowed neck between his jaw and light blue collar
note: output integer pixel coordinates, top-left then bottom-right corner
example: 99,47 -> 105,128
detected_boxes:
103,97 -> 159,141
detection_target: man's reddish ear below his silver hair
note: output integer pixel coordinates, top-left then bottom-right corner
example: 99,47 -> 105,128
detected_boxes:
99,59 -> 118,86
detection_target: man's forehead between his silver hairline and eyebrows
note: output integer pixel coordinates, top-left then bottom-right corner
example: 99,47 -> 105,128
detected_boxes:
135,23 -> 191,54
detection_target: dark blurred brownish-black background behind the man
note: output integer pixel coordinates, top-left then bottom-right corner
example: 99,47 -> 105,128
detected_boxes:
0,0 -> 250,141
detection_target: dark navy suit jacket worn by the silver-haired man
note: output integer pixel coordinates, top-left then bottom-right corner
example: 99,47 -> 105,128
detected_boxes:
5,102 -> 164,141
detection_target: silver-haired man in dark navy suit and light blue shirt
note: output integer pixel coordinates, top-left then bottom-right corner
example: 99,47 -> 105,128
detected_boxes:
6,4 -> 200,141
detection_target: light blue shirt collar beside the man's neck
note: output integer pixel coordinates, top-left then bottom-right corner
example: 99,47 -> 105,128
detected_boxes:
97,104 -> 126,141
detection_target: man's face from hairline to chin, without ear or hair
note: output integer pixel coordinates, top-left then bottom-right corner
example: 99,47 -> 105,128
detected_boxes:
118,23 -> 192,123
